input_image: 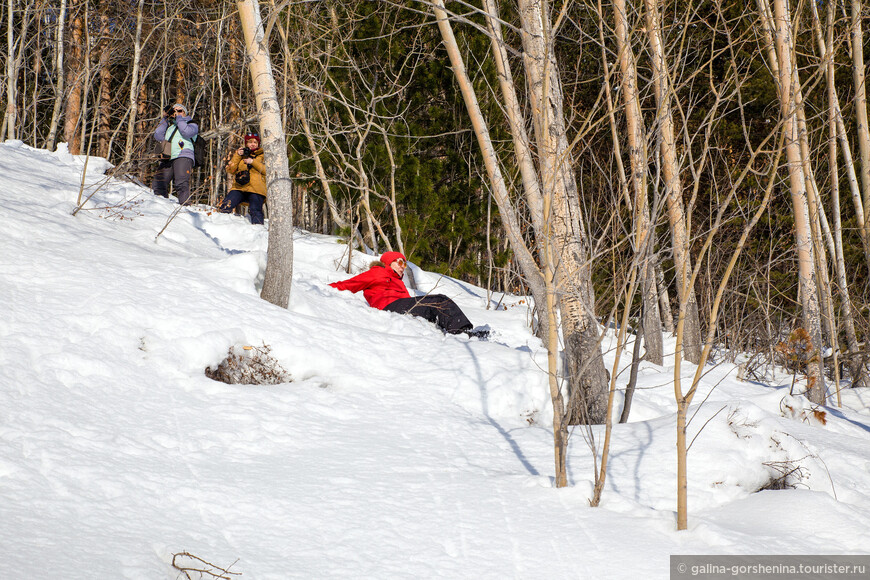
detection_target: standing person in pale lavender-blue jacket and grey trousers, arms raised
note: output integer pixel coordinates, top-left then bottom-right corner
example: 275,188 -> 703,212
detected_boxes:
151,103 -> 199,205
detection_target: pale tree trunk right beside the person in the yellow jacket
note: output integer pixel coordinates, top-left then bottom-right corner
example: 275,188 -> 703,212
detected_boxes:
238,0 -> 293,308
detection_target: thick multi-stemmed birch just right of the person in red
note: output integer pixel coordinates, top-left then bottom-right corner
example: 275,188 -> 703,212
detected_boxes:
432,0 -> 607,446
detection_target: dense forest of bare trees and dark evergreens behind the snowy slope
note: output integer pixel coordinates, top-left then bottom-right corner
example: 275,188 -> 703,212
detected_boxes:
0,0 -> 870,402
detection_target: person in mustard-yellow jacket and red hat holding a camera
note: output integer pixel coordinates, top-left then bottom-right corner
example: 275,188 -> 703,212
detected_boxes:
219,133 -> 266,224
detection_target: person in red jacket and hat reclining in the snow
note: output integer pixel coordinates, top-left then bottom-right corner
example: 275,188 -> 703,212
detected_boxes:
330,252 -> 489,338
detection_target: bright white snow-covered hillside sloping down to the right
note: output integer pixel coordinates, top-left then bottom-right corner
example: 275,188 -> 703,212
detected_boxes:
0,141 -> 870,580
